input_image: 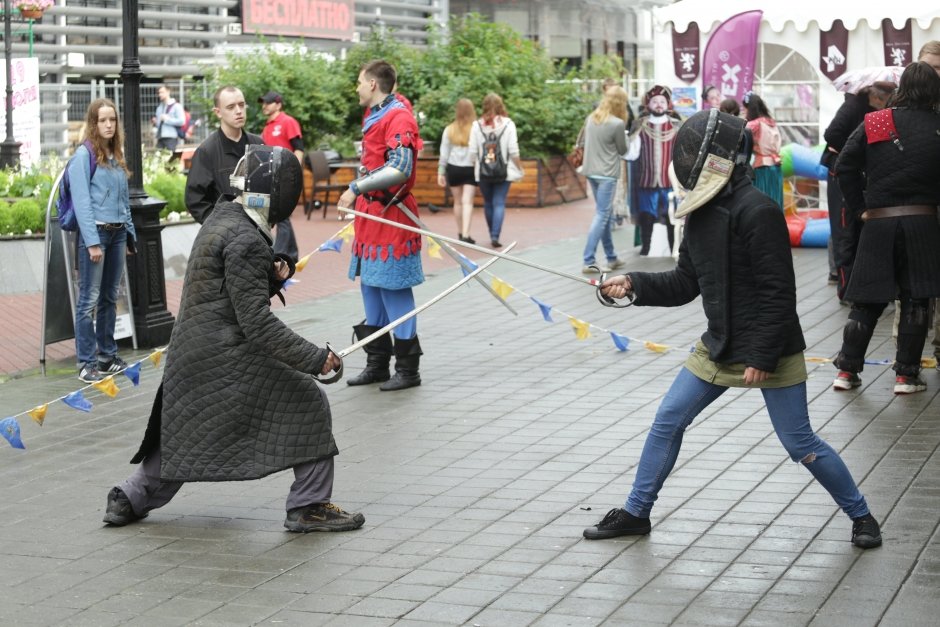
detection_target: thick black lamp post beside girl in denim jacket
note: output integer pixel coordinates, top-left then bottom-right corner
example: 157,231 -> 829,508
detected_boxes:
119,0 -> 174,348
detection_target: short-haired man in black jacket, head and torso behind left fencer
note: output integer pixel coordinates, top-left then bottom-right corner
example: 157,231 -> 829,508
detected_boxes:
186,85 -> 264,224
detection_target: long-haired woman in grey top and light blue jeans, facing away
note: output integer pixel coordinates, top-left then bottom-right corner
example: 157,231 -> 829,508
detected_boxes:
581,86 -> 627,274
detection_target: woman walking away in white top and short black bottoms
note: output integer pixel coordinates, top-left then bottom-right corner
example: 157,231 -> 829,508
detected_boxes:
437,98 -> 477,244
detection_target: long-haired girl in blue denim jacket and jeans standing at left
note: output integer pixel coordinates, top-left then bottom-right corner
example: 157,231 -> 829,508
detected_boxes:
67,98 -> 137,383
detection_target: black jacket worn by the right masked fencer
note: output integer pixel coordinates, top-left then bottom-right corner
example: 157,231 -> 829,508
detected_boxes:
630,172 -> 806,372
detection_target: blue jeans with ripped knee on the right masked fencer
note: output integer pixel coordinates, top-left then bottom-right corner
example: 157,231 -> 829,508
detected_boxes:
624,368 -> 868,518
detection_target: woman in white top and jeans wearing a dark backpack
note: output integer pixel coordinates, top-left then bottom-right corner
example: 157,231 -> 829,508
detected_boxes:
470,92 -> 525,248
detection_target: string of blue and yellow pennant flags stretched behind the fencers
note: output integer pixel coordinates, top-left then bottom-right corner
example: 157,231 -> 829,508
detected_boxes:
9,222 -> 937,449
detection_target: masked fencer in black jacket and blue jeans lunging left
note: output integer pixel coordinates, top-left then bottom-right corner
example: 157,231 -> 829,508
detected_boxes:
584,109 -> 881,548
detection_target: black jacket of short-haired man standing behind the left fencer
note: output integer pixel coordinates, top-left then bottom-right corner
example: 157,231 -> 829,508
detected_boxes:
186,129 -> 264,224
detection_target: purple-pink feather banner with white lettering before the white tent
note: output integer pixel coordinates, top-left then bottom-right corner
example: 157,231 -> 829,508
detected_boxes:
702,11 -> 764,102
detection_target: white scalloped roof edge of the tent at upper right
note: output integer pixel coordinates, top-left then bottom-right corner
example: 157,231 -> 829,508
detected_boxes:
653,0 -> 940,33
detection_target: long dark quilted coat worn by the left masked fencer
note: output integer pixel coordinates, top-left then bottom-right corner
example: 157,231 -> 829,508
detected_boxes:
132,202 -> 337,481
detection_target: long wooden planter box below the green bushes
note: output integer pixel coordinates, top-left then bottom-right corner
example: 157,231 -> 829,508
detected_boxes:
324,156 -> 587,207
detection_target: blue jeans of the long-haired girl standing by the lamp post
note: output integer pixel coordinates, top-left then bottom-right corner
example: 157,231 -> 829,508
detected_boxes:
75,226 -> 127,367
